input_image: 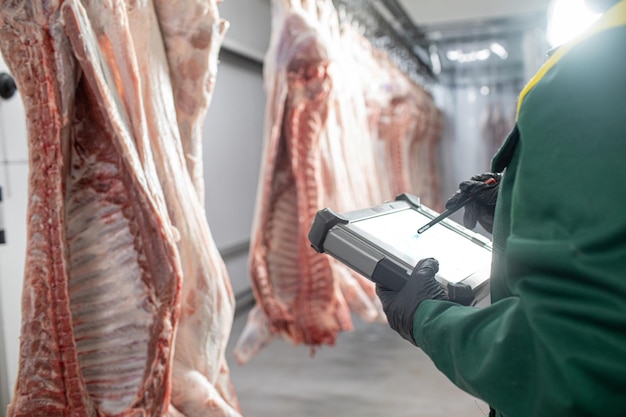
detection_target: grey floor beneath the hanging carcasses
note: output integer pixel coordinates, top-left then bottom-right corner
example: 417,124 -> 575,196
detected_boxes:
228,306 -> 488,417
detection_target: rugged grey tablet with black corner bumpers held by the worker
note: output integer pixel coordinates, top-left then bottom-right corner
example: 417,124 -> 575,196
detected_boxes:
309,194 -> 491,305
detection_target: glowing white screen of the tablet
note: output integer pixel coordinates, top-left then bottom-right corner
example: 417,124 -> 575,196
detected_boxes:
351,210 -> 491,282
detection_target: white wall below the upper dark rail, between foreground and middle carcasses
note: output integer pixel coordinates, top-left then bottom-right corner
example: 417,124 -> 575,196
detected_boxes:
203,53 -> 265,294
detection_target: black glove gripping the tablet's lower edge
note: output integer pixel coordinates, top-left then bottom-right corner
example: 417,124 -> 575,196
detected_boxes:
376,258 -> 448,345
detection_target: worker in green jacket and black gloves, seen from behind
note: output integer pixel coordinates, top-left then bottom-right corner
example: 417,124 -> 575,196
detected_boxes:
377,0 -> 626,417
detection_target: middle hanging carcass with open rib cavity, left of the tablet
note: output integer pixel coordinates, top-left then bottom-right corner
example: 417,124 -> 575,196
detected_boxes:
239,0 -> 351,361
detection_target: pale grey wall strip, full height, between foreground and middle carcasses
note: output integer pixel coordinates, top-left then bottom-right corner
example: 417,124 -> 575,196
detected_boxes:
203,0 -> 271,305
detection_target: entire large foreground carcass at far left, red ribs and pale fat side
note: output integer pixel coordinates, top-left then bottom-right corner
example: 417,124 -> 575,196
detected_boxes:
0,0 -> 239,417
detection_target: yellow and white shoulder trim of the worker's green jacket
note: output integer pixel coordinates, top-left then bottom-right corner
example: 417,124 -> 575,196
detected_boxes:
515,0 -> 626,120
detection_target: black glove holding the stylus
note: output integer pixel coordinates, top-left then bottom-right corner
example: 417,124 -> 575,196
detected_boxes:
446,172 -> 502,233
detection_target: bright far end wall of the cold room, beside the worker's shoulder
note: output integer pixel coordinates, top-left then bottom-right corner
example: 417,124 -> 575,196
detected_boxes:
425,13 -> 549,231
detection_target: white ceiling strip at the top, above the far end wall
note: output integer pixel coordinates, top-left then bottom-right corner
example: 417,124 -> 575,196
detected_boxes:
399,0 -> 550,26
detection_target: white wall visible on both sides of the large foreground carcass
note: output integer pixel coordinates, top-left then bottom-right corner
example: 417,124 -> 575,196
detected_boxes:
0,0 -> 270,410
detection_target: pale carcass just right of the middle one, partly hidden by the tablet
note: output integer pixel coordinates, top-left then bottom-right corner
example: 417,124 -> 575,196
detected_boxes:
322,25 -> 392,322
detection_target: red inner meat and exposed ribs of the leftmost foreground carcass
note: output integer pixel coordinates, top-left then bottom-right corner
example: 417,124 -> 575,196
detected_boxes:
0,3 -> 181,416
